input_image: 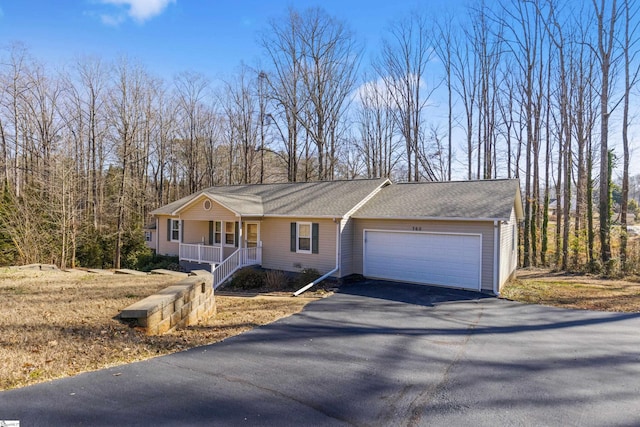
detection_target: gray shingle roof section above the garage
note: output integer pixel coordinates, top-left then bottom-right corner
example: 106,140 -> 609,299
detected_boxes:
353,179 -> 522,220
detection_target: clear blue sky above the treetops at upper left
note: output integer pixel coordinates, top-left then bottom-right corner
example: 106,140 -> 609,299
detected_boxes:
0,0 -> 460,79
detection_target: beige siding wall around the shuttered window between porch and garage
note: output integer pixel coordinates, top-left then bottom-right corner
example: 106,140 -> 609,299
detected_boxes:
260,218 -> 338,274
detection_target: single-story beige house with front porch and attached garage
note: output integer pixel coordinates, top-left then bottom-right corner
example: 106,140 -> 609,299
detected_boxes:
149,179 -> 523,294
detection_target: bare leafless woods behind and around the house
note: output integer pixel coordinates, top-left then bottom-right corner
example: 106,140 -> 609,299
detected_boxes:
0,0 -> 640,274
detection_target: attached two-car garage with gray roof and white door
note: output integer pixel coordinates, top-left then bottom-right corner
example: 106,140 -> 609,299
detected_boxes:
350,180 -> 523,294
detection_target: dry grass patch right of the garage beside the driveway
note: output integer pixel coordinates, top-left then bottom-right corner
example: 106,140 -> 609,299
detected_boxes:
500,269 -> 640,312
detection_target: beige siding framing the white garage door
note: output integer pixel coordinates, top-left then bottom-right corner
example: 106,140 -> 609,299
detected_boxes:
353,219 -> 494,291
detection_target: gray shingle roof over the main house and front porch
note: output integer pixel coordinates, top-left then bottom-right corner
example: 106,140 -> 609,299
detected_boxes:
151,179 -> 388,217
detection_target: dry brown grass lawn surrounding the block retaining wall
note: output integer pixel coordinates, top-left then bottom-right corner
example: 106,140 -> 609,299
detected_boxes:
0,269 -> 311,390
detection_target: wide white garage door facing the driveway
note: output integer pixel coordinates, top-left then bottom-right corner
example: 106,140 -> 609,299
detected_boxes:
363,230 -> 482,290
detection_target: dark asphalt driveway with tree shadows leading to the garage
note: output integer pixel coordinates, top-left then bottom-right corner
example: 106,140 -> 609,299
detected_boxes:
0,282 -> 640,426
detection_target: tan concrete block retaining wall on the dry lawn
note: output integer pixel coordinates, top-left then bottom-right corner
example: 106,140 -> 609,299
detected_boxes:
120,271 -> 216,335
